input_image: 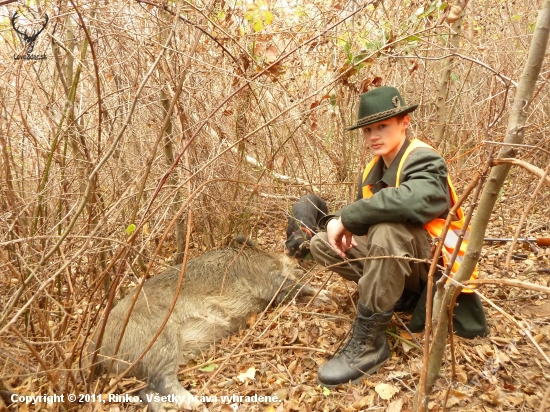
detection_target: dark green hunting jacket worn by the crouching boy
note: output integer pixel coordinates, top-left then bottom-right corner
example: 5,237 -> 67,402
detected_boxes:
321,140 -> 489,338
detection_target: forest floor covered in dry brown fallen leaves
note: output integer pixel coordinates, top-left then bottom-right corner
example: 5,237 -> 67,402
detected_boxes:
83,217 -> 550,412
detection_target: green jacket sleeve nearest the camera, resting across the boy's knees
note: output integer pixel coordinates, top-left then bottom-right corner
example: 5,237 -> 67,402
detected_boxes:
341,148 -> 449,236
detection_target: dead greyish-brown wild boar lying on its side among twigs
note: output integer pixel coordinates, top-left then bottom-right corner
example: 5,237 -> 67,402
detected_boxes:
91,245 -> 326,411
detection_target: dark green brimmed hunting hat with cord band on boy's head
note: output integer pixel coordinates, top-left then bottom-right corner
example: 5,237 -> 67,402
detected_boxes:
348,86 -> 418,130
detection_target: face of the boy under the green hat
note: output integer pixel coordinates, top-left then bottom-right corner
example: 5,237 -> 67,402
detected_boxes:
362,115 -> 411,166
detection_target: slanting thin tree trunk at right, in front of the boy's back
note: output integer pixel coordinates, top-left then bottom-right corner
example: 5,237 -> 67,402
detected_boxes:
418,0 -> 550,411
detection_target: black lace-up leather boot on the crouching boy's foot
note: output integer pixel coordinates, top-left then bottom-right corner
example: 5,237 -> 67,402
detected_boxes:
317,302 -> 393,388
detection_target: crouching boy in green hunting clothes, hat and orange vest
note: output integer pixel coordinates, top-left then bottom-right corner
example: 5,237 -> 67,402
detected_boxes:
311,86 -> 488,387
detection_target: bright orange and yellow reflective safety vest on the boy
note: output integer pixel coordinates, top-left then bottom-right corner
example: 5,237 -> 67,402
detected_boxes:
362,139 -> 478,293
